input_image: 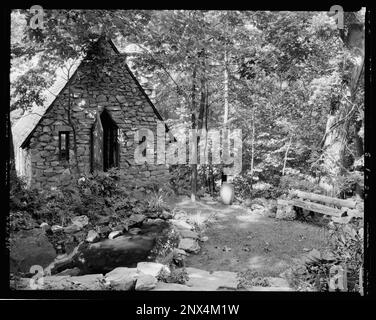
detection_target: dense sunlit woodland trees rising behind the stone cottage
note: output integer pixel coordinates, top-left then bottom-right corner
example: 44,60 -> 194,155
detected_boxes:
11,10 -> 364,197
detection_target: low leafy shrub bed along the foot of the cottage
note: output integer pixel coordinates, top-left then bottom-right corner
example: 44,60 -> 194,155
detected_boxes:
10,169 -> 171,231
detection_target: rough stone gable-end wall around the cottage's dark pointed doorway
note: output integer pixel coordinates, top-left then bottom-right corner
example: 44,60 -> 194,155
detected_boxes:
27,38 -> 168,187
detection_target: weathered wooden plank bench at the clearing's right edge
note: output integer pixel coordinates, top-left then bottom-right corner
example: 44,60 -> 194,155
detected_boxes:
278,190 -> 358,218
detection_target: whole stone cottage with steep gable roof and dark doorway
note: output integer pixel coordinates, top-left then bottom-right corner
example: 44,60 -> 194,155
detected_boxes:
12,37 -> 168,188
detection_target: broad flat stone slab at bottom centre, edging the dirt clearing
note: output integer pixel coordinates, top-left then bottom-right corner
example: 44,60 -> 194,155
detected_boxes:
186,267 -> 238,291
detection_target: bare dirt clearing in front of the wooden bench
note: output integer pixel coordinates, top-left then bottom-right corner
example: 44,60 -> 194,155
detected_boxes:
170,198 -> 327,277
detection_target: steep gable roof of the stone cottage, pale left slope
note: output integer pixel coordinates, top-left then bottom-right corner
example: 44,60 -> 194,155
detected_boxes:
18,38 -> 169,148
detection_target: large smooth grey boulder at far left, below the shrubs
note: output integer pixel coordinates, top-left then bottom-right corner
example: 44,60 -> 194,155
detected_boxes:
10,228 -> 57,273
